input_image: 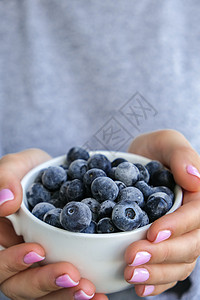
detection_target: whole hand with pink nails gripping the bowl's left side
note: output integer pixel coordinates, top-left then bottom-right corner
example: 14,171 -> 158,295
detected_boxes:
0,149 -> 108,300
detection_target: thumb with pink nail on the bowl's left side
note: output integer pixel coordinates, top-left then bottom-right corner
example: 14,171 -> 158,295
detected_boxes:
0,149 -> 51,217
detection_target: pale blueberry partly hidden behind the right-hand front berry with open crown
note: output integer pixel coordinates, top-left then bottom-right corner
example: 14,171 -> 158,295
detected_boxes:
117,186 -> 145,208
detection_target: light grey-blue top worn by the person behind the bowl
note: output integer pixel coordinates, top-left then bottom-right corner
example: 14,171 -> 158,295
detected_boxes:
0,0 -> 200,300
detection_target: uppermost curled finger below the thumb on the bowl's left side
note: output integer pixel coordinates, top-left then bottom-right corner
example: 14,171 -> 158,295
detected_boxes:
0,243 -> 45,284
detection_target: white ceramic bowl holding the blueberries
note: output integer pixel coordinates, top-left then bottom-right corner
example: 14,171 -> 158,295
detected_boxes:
9,151 -> 182,293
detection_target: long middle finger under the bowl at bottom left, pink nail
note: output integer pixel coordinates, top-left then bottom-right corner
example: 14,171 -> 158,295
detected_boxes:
1,262 -> 83,299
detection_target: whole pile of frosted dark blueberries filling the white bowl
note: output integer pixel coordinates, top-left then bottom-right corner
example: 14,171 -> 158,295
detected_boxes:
27,147 -> 175,233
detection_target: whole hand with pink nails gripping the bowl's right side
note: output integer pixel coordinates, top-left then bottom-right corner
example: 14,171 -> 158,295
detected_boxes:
124,130 -> 200,297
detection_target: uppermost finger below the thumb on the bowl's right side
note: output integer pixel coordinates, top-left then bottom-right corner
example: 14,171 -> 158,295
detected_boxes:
147,192 -> 200,242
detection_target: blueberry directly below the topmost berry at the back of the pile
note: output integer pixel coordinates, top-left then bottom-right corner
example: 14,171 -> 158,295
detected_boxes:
67,158 -> 87,180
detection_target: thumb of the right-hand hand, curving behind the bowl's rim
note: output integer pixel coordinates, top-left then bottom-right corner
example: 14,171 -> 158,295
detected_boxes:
129,130 -> 200,192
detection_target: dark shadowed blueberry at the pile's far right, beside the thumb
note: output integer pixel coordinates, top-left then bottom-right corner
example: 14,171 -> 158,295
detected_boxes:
151,169 -> 175,191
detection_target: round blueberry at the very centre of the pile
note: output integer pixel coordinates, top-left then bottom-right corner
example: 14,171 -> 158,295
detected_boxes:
91,177 -> 119,202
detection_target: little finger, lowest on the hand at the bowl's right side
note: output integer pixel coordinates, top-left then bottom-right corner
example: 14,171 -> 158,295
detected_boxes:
135,282 -> 177,297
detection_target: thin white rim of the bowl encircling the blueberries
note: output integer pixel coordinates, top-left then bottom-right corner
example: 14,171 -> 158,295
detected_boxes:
20,150 -> 183,239
